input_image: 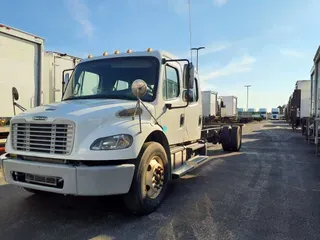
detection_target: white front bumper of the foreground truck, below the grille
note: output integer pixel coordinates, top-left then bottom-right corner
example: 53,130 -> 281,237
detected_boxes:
2,157 -> 135,196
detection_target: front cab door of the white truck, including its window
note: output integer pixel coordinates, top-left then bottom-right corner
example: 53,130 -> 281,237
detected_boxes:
157,62 -> 186,145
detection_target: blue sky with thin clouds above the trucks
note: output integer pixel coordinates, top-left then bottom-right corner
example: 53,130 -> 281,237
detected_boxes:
0,0 -> 320,108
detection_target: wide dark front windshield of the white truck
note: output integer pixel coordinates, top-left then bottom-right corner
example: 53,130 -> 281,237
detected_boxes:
63,57 -> 159,102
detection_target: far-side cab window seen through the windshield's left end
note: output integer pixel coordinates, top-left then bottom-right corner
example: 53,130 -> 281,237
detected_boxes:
79,72 -> 100,96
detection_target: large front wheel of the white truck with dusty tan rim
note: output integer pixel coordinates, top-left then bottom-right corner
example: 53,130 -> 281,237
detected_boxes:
124,142 -> 170,215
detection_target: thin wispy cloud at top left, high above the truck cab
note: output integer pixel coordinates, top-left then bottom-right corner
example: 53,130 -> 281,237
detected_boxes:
66,0 -> 94,37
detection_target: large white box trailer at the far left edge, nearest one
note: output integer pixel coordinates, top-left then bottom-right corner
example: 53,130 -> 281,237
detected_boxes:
0,24 -> 44,118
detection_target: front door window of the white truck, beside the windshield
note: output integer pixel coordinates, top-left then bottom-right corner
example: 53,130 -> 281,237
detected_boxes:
162,65 -> 179,100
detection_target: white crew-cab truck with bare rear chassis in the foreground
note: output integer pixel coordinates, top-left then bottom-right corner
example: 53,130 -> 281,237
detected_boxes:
0,48 -> 242,214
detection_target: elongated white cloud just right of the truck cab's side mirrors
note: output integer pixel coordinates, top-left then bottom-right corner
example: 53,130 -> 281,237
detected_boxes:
200,56 -> 256,81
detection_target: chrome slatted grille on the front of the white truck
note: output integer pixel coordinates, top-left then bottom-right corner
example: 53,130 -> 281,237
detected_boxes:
11,121 -> 74,155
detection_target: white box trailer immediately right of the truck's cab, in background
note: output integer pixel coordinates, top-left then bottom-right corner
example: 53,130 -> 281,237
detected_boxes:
201,91 -> 218,117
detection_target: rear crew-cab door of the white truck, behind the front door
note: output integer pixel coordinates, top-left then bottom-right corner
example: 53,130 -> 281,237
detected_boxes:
184,77 -> 202,142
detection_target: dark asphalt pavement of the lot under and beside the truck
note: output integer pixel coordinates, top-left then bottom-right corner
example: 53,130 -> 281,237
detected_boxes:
0,121 -> 320,240
